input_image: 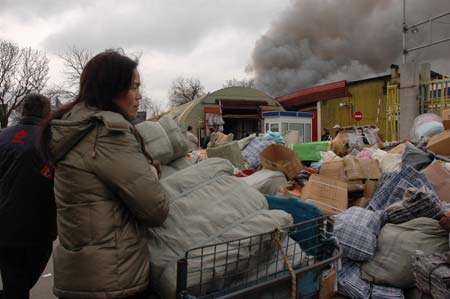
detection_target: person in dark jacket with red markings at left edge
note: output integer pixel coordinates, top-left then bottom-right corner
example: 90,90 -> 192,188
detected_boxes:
0,94 -> 56,299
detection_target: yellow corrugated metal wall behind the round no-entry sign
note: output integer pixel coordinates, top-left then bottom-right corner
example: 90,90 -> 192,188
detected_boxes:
321,79 -> 386,141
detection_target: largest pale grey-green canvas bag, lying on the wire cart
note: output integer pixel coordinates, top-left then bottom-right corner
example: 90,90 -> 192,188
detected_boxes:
148,158 -> 292,299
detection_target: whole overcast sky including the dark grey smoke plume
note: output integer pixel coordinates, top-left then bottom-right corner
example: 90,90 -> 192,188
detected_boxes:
0,0 -> 450,108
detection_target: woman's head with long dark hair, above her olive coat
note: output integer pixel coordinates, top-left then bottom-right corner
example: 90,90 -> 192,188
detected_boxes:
41,50 -> 138,163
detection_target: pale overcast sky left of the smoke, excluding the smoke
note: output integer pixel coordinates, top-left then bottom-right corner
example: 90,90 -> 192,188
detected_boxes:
0,0 -> 289,108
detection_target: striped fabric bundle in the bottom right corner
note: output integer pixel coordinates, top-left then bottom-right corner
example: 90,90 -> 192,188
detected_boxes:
412,253 -> 450,299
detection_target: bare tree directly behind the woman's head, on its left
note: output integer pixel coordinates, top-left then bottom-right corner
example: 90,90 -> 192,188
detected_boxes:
58,46 -> 92,89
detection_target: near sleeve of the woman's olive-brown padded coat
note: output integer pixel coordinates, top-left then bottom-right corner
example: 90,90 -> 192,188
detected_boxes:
88,128 -> 169,227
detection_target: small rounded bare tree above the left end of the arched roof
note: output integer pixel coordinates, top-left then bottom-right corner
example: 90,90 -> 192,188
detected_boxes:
169,77 -> 205,107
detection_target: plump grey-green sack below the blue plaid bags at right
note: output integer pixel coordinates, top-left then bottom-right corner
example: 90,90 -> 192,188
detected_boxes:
361,217 -> 449,289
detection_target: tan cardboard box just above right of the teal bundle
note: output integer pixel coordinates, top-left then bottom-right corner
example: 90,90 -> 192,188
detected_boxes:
302,174 -> 348,215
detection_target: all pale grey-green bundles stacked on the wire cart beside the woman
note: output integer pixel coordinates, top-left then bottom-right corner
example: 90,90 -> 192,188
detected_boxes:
137,118 -> 310,299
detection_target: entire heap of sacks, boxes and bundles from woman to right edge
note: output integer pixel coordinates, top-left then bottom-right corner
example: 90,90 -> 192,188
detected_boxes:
138,115 -> 450,299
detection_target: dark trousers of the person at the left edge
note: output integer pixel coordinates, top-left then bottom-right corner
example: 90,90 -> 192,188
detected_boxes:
0,243 -> 53,299
